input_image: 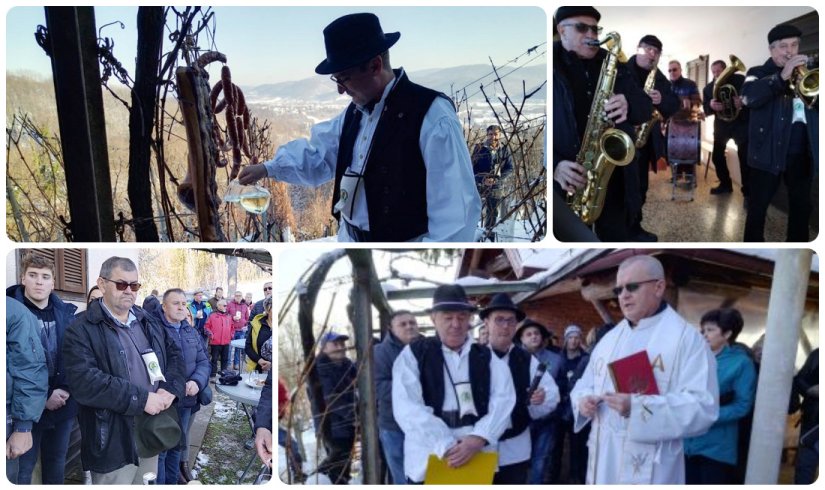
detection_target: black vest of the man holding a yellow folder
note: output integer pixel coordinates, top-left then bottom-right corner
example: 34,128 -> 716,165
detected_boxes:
410,337 -> 492,428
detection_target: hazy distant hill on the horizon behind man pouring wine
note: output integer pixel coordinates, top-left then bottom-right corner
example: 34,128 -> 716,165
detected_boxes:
242,64 -> 547,104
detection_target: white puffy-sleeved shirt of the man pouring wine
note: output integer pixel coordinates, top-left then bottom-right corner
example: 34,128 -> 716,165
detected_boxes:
264,69 -> 481,242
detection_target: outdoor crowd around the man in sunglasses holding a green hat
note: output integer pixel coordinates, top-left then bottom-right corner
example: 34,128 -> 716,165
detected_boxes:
6,252 -> 272,485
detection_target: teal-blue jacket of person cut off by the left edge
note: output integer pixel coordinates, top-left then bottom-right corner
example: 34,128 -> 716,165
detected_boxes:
6,296 -> 49,430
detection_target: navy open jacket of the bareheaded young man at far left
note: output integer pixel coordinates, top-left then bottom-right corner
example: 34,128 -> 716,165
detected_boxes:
6,284 -> 77,429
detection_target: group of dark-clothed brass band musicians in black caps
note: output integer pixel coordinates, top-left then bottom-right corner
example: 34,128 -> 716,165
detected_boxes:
553,6 -> 819,242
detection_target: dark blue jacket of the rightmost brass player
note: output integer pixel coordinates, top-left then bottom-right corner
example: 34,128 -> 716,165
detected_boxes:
742,59 -> 819,175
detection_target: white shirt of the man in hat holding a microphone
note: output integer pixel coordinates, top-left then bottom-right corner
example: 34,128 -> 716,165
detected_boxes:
493,345 -> 559,466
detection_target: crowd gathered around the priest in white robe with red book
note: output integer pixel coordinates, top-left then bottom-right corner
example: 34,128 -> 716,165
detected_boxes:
279,255 -> 819,484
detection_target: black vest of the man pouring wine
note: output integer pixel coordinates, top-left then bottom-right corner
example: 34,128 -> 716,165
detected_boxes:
332,70 -> 449,242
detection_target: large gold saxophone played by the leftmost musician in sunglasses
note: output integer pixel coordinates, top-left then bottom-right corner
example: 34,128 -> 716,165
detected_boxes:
567,32 -> 636,225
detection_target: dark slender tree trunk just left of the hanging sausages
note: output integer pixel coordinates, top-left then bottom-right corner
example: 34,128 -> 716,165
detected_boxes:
128,7 -> 165,242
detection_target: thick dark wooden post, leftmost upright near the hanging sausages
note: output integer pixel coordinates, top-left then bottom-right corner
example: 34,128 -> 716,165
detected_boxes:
45,7 -> 115,242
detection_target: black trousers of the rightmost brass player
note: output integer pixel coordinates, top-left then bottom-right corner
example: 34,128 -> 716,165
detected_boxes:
744,125 -> 813,242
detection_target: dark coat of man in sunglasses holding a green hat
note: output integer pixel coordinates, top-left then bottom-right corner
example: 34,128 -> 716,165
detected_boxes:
63,300 -> 186,473
